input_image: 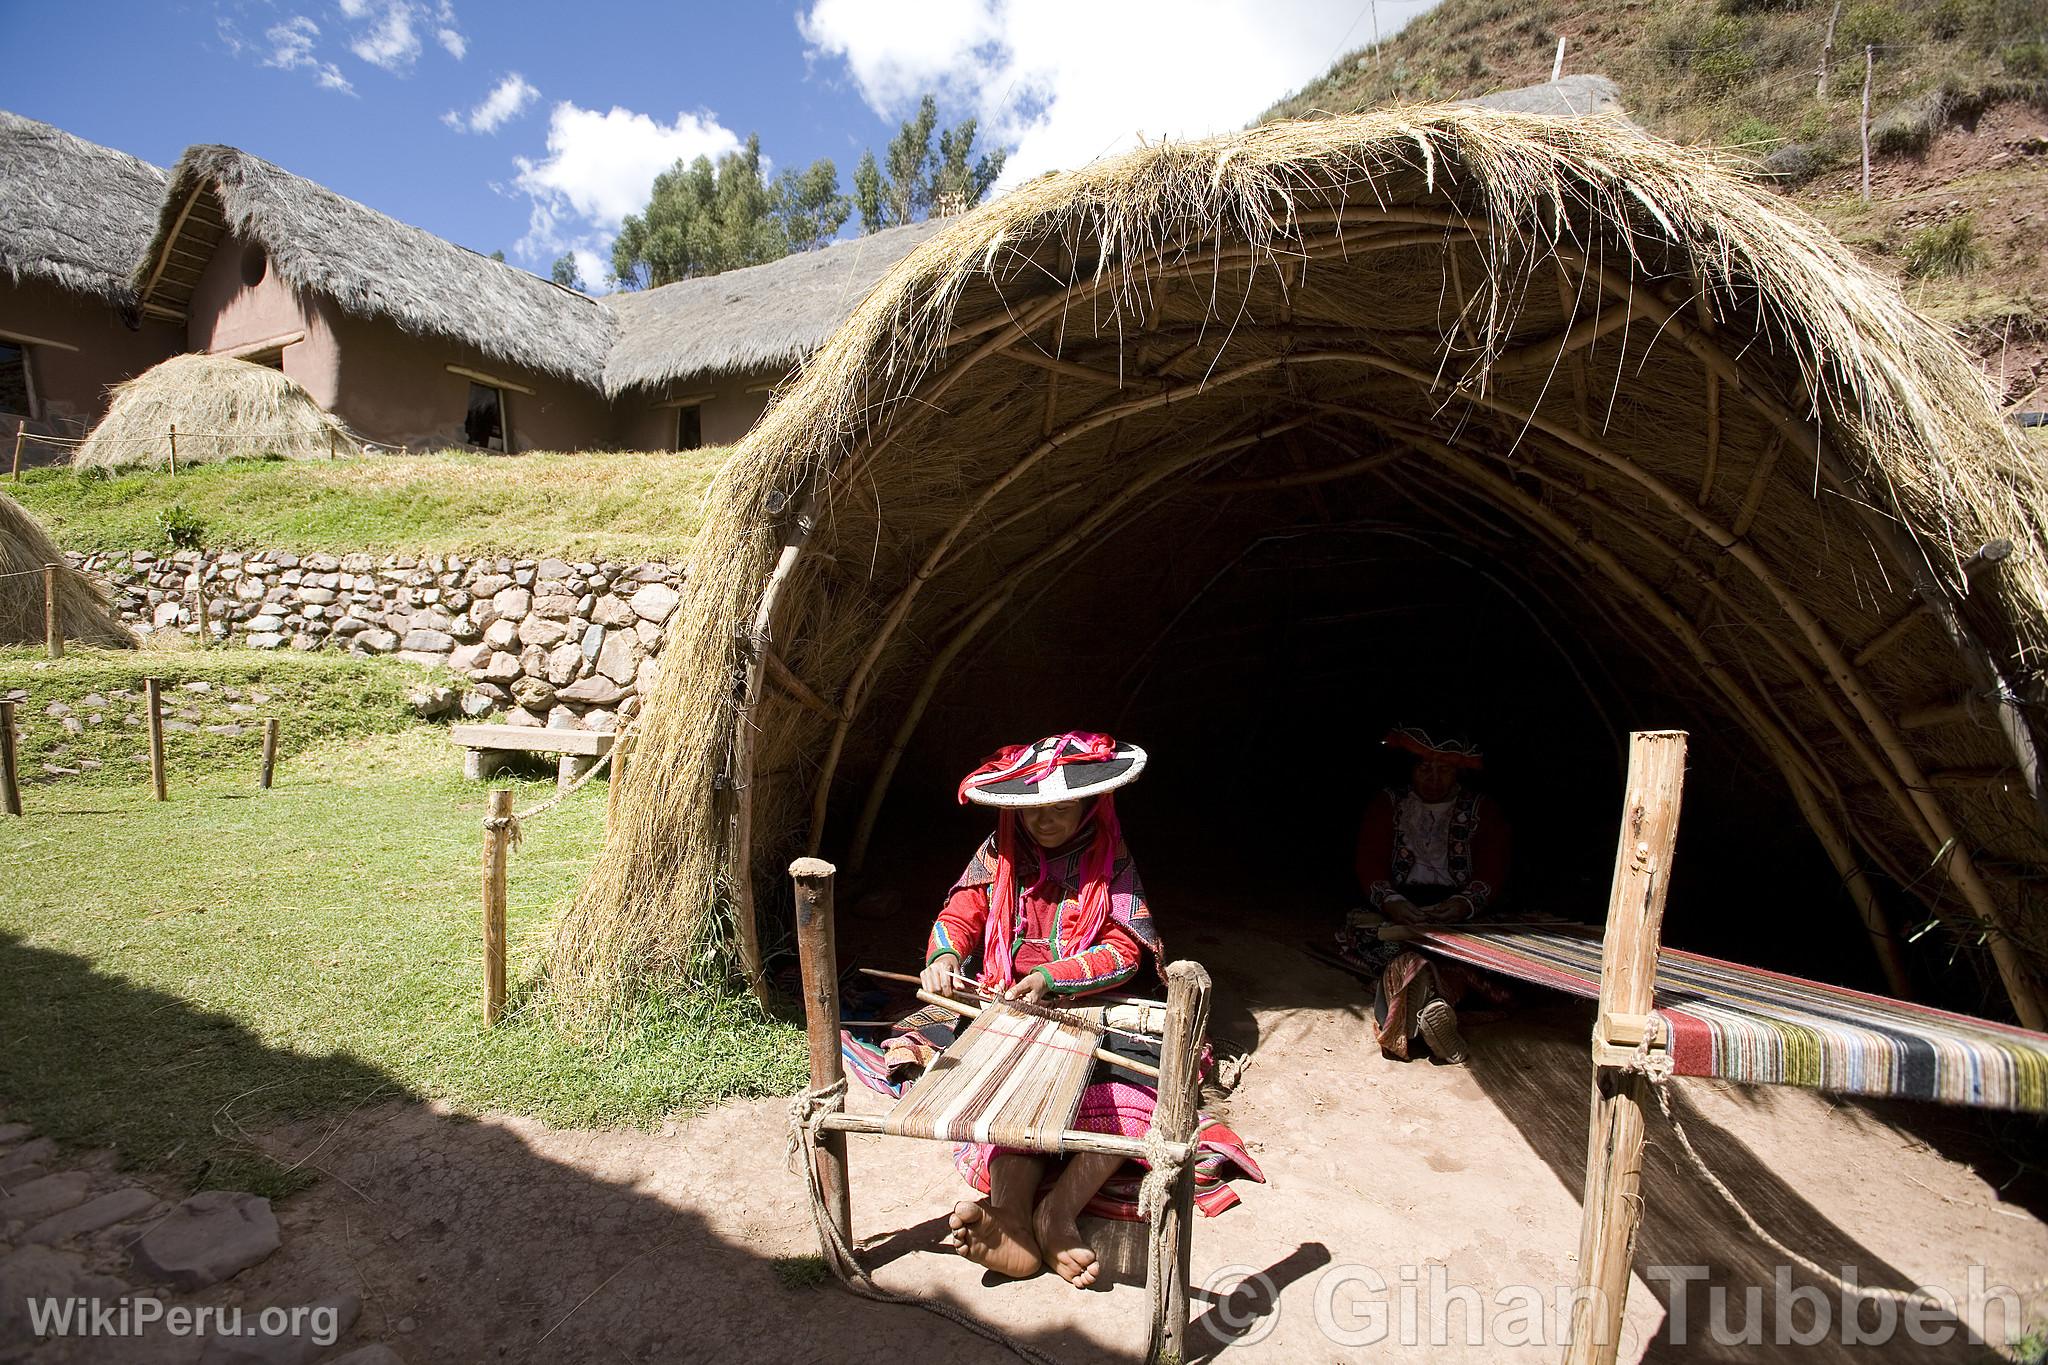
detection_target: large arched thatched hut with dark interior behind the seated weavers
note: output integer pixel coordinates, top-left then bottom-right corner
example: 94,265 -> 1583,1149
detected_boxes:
557,108 -> 2048,1027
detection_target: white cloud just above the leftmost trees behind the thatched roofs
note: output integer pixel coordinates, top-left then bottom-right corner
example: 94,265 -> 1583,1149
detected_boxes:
512,100 -> 739,246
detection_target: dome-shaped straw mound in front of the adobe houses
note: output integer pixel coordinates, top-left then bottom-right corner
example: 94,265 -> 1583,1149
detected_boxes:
72,354 -> 362,469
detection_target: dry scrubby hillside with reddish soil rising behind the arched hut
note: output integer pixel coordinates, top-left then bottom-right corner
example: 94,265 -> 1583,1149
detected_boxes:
1264,0 -> 2048,407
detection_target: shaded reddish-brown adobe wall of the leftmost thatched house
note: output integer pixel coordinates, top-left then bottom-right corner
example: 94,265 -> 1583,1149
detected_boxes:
0,274 -> 180,454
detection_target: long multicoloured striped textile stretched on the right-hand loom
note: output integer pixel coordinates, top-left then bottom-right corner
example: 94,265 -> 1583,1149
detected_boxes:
1411,927 -> 2048,1113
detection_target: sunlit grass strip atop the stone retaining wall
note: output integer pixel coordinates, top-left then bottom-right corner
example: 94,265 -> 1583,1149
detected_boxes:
6,446 -> 729,561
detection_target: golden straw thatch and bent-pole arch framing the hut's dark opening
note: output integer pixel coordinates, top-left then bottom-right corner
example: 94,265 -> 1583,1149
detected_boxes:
553,106 -> 2048,1021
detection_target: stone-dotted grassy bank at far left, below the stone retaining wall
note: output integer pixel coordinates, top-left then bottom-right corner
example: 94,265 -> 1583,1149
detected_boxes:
0,647 -> 461,789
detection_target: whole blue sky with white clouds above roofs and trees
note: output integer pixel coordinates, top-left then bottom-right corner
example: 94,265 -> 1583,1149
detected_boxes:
0,0 -> 1432,287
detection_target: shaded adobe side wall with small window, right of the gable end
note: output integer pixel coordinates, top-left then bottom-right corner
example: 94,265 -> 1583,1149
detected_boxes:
330,309 -> 612,450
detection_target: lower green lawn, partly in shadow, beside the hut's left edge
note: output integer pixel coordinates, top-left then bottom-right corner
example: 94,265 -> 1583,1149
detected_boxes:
0,720 -> 805,1195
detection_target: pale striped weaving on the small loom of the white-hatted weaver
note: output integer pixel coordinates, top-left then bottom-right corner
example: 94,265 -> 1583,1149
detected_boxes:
883,1003 -> 1102,1152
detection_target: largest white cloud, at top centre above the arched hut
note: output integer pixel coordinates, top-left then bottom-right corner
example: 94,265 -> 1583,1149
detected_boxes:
797,0 -> 1392,184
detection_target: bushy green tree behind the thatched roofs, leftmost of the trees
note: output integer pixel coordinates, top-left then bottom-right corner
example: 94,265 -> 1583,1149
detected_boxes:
612,135 -> 782,289
